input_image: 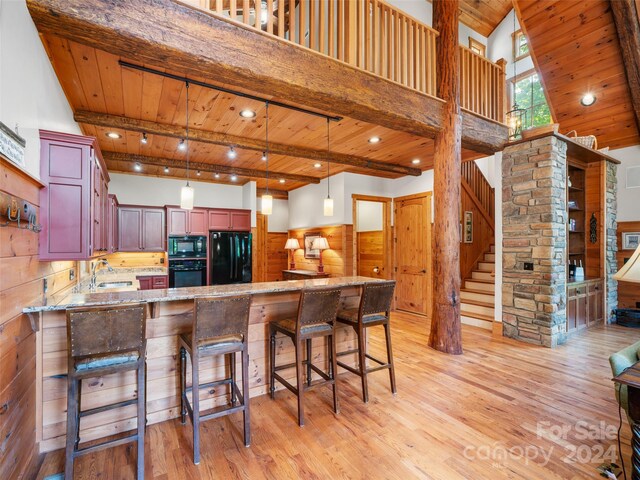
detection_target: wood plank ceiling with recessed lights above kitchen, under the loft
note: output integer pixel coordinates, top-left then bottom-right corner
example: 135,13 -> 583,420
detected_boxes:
42,34 -> 482,191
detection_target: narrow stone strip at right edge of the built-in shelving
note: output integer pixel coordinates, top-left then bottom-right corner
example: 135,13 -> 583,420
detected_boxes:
605,162 -> 618,321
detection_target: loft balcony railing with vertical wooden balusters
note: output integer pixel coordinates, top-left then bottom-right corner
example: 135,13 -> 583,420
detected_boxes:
187,0 -> 506,123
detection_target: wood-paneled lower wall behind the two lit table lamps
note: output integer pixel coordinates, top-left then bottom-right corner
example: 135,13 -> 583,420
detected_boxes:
289,225 -> 353,277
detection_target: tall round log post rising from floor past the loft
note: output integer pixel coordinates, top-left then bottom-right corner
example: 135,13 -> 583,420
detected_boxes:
429,0 -> 462,355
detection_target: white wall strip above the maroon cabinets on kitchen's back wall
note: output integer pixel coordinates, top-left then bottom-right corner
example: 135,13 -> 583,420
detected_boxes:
109,173 -> 245,208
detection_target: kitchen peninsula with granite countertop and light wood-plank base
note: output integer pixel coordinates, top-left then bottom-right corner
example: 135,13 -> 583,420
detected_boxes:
23,277 -> 380,452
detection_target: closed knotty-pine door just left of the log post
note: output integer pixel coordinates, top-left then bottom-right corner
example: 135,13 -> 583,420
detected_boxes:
394,192 -> 432,315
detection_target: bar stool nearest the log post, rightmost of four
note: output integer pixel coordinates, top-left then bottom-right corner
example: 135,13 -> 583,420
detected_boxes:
337,281 -> 396,403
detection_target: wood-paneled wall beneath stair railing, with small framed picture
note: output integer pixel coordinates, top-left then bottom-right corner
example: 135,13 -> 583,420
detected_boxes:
460,181 -> 494,280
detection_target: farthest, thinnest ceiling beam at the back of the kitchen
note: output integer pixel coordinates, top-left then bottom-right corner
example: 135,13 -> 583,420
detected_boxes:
102,152 -> 320,183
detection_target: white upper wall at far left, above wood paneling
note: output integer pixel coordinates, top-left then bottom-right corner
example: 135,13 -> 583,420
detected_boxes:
0,0 -> 81,177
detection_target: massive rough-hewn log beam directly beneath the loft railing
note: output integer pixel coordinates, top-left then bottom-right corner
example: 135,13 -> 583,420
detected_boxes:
27,0 -> 507,153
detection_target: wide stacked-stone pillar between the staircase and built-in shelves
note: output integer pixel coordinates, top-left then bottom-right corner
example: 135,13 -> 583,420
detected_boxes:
502,136 -> 567,347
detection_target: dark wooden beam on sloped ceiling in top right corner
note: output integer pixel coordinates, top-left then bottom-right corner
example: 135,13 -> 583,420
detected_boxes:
611,0 -> 640,135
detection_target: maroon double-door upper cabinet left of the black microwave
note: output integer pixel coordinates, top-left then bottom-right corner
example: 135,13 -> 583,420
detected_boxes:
118,205 -> 166,252
